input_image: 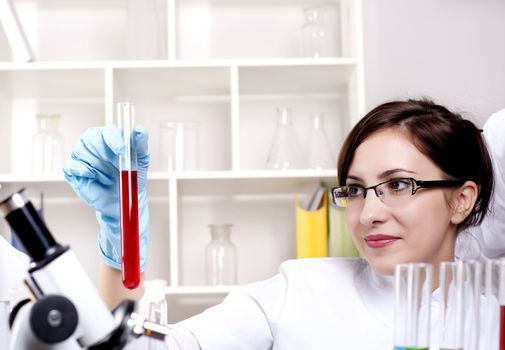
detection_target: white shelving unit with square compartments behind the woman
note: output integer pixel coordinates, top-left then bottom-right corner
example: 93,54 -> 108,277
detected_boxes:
0,0 -> 364,321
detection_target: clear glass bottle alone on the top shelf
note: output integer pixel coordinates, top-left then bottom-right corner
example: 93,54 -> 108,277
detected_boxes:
300,5 -> 328,58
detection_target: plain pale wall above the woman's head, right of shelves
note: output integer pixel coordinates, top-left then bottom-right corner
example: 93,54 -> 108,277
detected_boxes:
363,0 -> 505,124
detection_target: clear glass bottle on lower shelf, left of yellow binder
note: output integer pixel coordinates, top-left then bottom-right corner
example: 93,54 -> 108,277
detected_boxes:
205,224 -> 237,286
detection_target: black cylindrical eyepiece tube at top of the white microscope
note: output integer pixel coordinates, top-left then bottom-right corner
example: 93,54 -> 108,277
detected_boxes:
0,189 -> 62,263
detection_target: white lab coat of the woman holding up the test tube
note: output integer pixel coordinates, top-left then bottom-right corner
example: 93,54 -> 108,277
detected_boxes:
167,110 -> 505,350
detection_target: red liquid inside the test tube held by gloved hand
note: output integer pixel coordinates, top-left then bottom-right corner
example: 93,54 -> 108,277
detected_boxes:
119,171 -> 140,289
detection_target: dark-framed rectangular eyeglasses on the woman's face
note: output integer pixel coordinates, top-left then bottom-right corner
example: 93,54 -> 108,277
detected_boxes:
331,177 -> 466,208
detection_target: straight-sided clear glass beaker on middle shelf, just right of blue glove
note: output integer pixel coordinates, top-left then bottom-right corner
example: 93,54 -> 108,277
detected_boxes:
159,121 -> 199,171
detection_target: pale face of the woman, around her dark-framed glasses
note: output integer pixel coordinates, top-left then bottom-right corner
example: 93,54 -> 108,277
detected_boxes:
345,130 -> 456,275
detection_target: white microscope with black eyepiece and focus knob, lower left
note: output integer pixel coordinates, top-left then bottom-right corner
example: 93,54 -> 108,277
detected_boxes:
0,190 -> 169,350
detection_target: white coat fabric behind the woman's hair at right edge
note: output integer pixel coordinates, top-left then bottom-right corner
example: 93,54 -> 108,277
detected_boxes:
463,109 -> 505,258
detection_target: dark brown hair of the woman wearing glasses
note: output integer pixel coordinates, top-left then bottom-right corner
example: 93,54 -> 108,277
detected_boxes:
338,99 -> 493,230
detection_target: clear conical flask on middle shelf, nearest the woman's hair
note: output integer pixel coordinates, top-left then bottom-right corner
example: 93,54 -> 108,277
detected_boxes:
305,113 -> 337,170
